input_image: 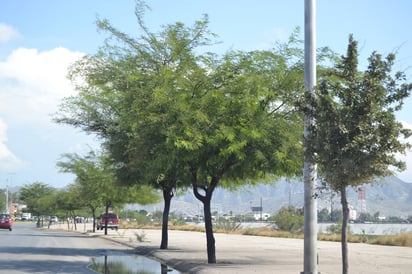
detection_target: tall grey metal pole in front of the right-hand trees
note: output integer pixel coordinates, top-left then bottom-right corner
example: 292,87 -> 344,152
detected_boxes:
301,0 -> 318,274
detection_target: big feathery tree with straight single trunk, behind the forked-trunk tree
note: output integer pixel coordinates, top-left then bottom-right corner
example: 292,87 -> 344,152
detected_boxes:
56,2 -> 217,248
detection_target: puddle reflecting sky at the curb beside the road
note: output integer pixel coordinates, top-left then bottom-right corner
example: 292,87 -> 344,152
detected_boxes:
89,254 -> 181,274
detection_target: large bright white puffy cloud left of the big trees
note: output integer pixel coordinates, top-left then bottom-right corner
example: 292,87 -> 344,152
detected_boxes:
0,48 -> 83,123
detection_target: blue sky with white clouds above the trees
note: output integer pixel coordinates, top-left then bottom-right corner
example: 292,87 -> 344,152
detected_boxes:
0,0 -> 412,188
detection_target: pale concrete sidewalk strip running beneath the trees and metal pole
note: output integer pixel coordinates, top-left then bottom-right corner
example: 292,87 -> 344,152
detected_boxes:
51,224 -> 412,274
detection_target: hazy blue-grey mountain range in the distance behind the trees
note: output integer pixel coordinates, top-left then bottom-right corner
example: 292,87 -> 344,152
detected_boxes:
138,177 -> 412,217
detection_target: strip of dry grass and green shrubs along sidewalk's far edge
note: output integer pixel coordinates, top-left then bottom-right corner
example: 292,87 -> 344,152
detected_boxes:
114,206 -> 412,247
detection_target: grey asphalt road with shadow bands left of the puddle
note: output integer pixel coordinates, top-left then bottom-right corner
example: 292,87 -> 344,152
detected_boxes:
0,223 -> 132,274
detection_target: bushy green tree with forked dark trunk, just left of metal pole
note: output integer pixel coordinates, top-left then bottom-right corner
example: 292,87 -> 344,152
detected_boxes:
179,47 -> 302,263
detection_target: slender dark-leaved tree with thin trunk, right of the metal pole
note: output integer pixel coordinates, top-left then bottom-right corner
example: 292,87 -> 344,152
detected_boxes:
307,35 -> 412,273
